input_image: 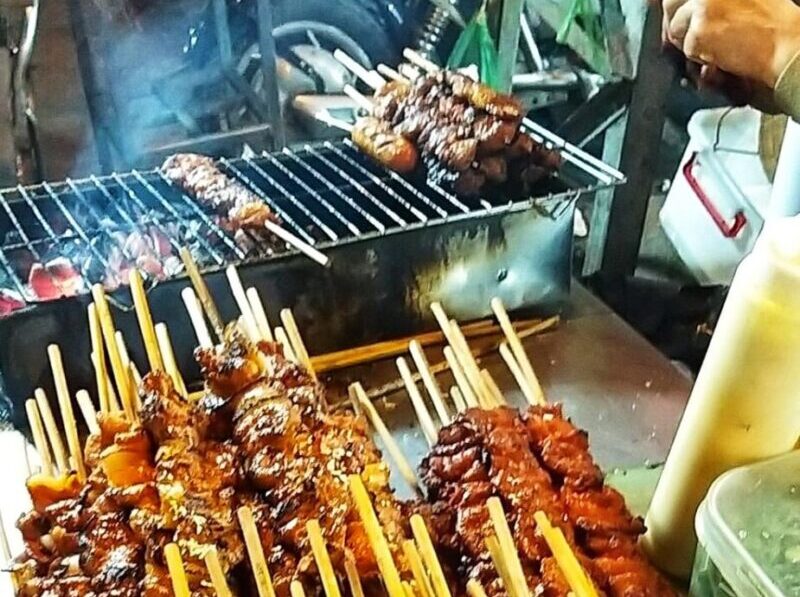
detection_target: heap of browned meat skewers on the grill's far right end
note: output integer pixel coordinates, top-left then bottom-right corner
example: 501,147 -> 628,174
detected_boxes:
322,52 -> 561,197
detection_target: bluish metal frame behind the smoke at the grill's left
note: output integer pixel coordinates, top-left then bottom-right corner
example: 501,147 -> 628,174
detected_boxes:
68,0 -> 285,173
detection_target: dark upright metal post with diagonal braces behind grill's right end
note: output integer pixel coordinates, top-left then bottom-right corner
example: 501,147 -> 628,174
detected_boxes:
520,0 -> 676,276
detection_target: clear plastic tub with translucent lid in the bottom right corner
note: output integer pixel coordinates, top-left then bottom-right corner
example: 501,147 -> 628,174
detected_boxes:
696,452 -> 800,597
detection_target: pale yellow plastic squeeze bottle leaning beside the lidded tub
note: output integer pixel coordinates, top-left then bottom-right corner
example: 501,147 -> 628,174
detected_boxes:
643,217 -> 800,578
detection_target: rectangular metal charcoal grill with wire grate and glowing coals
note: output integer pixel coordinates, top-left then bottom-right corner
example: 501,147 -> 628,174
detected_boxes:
0,131 -> 624,425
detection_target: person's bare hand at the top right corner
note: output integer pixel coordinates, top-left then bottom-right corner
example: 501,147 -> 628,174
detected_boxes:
663,0 -> 800,88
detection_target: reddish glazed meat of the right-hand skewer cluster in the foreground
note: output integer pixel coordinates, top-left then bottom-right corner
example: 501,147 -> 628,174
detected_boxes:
421,406 -> 676,597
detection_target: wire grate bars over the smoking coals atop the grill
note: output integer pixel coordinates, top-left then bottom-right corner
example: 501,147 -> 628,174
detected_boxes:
0,141 -> 490,304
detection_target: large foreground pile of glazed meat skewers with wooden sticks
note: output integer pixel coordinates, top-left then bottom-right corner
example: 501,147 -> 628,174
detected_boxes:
4,254 -> 672,597
